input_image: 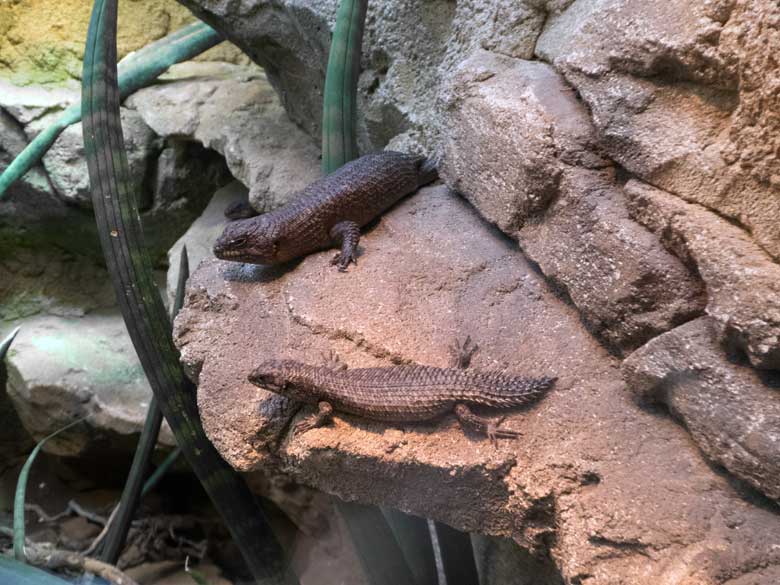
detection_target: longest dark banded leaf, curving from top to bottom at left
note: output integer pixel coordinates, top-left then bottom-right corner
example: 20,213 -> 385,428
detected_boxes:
82,0 -> 298,585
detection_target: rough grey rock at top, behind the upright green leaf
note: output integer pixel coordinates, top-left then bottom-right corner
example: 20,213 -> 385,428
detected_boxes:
174,0 -> 566,151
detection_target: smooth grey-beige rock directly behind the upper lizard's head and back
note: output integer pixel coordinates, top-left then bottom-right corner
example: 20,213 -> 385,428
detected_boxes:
127,63 -> 320,212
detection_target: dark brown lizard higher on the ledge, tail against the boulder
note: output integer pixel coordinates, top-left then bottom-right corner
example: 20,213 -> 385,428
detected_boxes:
214,151 -> 437,271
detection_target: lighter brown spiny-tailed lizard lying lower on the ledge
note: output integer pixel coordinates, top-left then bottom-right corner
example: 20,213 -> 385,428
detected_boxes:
249,341 -> 555,439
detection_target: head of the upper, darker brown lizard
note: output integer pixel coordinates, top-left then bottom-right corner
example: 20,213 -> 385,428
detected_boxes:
214,216 -> 279,264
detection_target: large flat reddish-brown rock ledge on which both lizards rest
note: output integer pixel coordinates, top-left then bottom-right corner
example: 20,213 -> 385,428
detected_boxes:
176,187 -> 780,585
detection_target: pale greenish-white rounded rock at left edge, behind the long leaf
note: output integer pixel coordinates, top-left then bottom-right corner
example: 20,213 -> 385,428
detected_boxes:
3,310 -> 174,456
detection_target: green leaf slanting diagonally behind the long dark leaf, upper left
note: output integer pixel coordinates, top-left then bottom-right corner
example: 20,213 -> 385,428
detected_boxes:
0,22 -> 222,199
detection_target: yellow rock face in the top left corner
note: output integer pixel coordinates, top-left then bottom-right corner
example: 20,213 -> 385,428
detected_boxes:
0,0 -> 244,85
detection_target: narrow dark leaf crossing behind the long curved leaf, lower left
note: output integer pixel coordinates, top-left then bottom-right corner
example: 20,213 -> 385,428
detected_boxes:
100,246 -> 190,565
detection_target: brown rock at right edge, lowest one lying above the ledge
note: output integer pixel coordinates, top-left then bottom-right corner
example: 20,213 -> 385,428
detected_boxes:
623,317 -> 780,500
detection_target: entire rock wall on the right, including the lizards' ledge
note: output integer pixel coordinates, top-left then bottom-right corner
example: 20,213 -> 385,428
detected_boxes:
166,0 -> 780,585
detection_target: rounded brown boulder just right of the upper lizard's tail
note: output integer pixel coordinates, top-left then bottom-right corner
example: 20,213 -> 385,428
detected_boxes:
441,51 -> 610,234
